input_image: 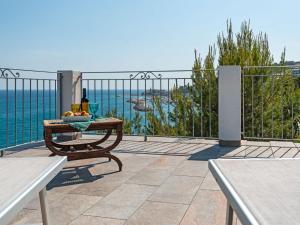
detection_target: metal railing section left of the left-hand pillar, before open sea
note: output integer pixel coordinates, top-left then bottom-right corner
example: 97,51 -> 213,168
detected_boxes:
0,68 -> 57,149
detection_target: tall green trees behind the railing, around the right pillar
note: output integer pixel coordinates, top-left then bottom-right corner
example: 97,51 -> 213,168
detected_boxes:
147,21 -> 300,138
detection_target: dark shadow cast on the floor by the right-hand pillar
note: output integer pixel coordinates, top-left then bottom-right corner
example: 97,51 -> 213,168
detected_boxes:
188,145 -> 240,161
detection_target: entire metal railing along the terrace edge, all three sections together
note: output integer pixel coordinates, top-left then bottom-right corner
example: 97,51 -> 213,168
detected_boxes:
0,66 -> 300,149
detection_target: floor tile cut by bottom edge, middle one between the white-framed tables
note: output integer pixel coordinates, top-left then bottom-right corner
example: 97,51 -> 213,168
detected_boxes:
126,201 -> 188,225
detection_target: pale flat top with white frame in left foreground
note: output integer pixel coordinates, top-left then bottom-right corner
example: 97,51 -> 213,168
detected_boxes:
0,157 -> 67,225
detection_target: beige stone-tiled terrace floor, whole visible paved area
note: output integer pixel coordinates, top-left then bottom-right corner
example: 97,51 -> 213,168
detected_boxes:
6,137 -> 300,225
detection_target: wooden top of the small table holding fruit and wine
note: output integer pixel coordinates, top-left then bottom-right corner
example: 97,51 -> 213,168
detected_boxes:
44,117 -> 123,128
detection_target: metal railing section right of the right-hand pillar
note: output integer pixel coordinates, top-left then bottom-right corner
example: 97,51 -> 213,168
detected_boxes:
242,66 -> 300,140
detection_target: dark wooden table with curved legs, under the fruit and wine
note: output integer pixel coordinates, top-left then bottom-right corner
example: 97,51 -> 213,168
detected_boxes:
44,118 -> 123,171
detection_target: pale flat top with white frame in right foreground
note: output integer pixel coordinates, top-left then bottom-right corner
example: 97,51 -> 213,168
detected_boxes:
209,159 -> 300,225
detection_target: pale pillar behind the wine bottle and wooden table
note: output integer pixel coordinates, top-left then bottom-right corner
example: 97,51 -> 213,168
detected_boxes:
57,70 -> 82,118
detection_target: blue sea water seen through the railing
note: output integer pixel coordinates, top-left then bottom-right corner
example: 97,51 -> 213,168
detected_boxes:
0,90 -> 167,148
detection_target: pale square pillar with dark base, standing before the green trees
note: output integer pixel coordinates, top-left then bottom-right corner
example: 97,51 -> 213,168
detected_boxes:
218,66 -> 241,146
